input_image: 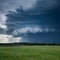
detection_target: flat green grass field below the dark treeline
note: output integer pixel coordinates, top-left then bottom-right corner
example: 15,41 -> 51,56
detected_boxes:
0,46 -> 60,60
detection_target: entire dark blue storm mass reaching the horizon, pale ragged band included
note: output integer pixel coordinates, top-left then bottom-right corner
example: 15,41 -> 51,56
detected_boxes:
6,0 -> 60,43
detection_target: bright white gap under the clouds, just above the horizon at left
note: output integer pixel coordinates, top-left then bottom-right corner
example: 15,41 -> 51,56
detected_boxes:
0,34 -> 22,43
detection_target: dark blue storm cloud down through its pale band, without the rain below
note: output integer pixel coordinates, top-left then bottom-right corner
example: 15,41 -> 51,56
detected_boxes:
6,0 -> 60,34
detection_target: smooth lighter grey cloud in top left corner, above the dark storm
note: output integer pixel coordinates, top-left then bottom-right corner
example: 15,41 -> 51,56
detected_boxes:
0,0 -> 35,13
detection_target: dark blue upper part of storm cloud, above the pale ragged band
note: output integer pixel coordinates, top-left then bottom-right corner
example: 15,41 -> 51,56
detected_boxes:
7,0 -> 60,25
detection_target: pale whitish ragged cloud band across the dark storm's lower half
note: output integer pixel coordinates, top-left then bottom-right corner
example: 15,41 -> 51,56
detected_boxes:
13,26 -> 56,36
